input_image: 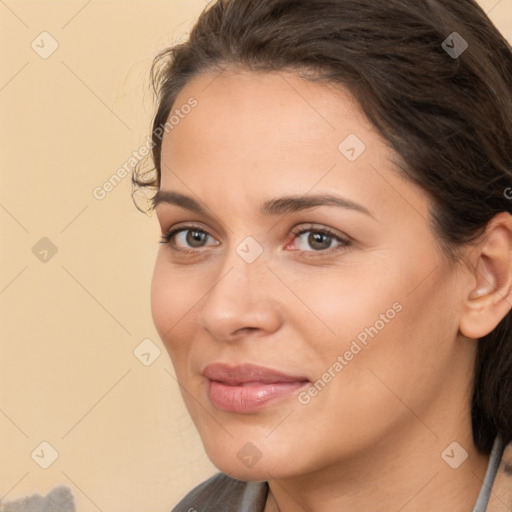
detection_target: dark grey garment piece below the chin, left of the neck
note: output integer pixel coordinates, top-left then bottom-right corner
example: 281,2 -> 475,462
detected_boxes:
172,473 -> 268,512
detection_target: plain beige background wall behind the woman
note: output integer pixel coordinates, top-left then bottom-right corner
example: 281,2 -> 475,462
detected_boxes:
0,0 -> 512,512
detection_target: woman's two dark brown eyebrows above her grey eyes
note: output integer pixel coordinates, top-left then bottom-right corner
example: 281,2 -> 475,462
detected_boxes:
152,190 -> 375,219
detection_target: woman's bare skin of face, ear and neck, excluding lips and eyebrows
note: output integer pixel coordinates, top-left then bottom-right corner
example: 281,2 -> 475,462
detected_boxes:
151,70 -> 512,512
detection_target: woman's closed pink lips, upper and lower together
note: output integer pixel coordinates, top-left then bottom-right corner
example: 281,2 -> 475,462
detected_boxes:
203,363 -> 309,413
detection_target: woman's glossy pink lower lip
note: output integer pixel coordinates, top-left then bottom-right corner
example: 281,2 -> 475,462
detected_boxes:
208,379 -> 309,412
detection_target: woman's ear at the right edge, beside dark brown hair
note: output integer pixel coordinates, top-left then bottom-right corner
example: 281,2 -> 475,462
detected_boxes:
459,212 -> 512,339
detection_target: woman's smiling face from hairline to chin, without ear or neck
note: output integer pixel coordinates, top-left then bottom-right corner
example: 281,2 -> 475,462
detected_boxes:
152,72 -> 474,480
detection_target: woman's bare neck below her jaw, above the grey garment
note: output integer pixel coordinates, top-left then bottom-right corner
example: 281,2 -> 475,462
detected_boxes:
265,424 -> 489,512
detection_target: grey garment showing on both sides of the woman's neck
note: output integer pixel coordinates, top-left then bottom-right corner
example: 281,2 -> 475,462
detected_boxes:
172,436 -> 505,512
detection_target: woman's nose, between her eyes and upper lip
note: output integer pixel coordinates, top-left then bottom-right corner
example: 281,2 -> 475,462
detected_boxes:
197,250 -> 282,341
